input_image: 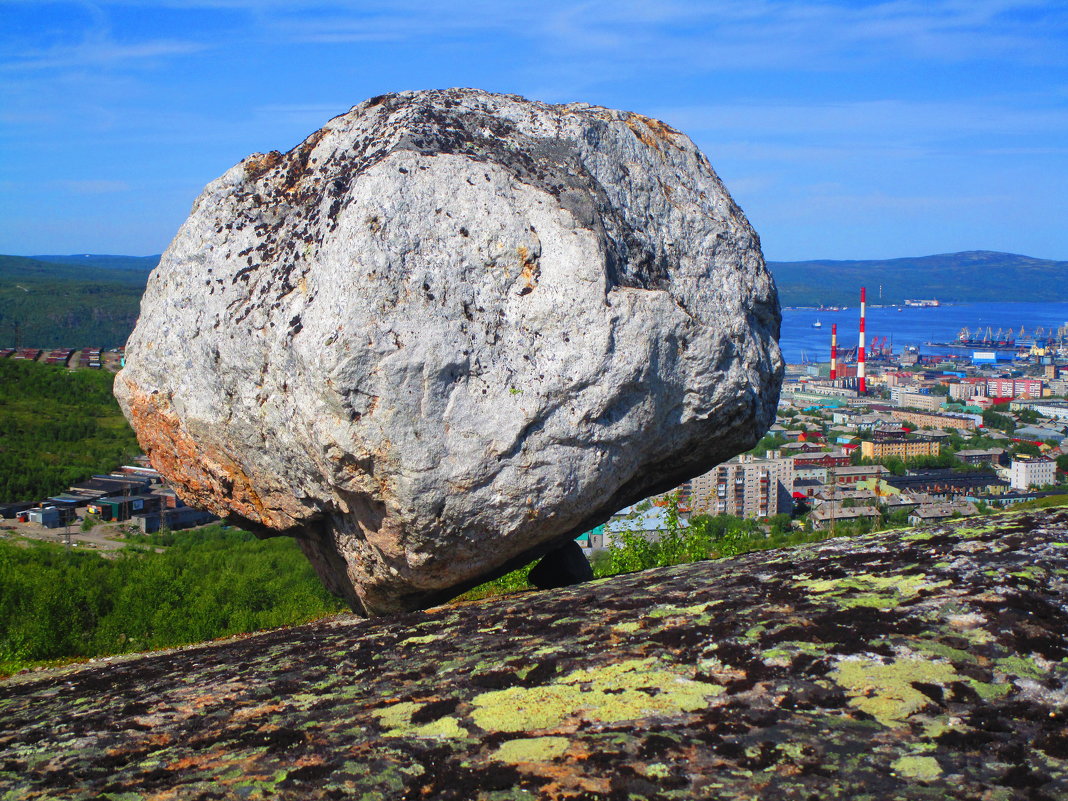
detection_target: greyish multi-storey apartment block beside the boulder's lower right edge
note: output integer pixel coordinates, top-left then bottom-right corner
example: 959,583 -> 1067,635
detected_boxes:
690,451 -> 794,517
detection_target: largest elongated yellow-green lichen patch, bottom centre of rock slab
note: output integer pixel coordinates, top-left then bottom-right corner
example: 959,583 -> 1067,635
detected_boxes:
471,659 -> 723,732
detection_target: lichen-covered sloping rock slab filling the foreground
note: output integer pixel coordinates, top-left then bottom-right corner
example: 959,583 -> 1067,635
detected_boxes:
0,509 -> 1068,801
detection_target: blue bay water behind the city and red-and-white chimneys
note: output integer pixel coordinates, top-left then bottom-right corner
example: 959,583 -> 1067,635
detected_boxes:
779,295 -> 1068,364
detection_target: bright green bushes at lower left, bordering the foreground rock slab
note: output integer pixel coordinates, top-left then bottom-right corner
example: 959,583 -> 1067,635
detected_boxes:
0,525 -> 342,675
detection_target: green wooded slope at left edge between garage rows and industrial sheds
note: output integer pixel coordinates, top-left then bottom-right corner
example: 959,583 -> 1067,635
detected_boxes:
0,359 -> 140,503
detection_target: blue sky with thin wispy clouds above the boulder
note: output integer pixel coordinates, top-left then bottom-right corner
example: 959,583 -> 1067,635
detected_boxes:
0,0 -> 1068,260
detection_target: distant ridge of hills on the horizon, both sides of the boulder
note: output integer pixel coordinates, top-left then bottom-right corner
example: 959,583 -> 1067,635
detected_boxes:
0,250 -> 1068,347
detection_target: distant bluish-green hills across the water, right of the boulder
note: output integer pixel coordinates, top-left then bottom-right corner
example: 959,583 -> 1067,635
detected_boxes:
768,250 -> 1068,305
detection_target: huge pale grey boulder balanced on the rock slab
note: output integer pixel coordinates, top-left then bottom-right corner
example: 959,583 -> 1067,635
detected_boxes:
115,90 -> 782,614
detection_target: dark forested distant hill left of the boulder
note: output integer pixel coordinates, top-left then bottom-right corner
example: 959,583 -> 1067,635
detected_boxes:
0,255 -> 151,348
